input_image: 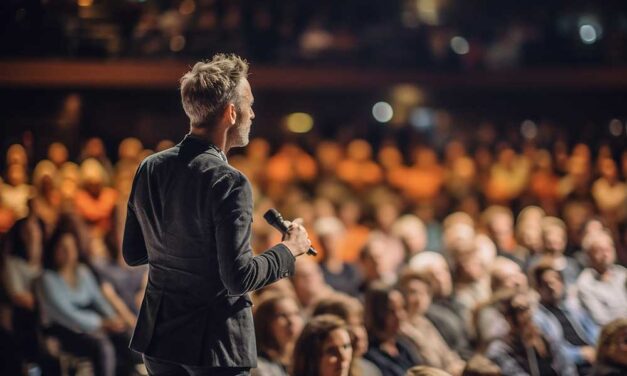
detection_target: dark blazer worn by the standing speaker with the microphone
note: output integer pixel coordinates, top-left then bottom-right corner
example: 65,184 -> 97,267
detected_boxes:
123,135 -> 295,367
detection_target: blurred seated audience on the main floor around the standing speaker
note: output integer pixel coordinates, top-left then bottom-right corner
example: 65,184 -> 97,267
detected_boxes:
0,131 -> 627,376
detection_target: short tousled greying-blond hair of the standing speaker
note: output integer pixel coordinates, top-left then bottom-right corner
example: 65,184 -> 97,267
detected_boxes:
180,54 -> 248,128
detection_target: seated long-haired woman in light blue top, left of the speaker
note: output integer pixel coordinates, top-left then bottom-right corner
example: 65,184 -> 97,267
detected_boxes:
41,229 -> 130,376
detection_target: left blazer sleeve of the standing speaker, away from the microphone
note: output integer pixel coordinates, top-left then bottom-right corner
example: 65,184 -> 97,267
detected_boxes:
122,164 -> 148,266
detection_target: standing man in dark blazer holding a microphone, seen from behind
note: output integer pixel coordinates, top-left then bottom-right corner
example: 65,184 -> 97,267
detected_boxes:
123,54 -> 311,375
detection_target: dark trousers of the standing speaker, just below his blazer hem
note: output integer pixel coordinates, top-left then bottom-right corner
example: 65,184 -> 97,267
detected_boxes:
144,354 -> 250,376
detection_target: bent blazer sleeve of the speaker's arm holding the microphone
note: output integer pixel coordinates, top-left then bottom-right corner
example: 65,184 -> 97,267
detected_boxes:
212,171 -> 295,296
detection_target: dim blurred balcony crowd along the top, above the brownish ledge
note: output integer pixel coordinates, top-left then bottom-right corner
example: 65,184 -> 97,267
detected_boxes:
0,0 -> 627,70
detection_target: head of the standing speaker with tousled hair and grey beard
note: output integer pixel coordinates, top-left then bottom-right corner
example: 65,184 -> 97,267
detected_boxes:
180,54 -> 255,146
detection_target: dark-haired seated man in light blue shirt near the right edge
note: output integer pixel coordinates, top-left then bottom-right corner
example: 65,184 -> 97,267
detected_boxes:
532,258 -> 599,375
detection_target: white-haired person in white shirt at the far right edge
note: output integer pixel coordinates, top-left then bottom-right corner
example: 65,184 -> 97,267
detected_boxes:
577,232 -> 627,325
